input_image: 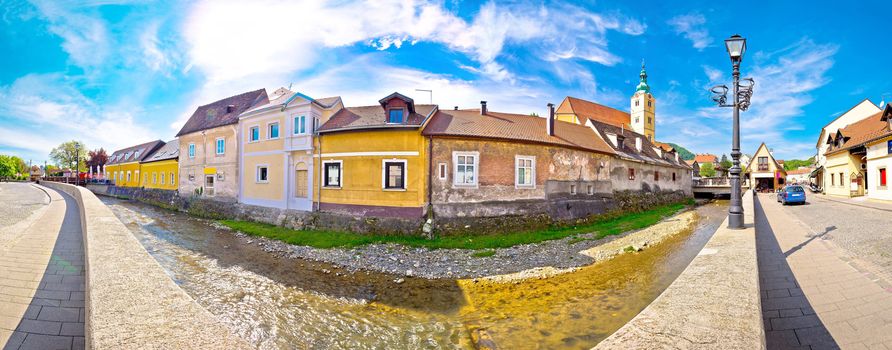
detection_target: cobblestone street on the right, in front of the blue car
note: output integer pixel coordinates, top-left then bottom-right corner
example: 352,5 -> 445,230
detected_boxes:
785,194 -> 892,288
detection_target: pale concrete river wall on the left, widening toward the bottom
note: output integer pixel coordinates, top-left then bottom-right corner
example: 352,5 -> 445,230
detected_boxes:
41,182 -> 252,349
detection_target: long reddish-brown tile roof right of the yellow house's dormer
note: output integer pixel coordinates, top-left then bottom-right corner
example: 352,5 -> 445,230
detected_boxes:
423,109 -> 614,154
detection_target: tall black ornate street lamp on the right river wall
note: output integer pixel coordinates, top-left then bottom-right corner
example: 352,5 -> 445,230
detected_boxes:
710,34 -> 756,229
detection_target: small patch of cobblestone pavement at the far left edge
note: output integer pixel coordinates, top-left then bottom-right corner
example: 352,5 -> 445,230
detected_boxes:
0,182 -> 49,231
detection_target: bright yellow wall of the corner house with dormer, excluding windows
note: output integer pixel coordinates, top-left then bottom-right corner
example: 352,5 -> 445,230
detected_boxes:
314,129 -> 428,207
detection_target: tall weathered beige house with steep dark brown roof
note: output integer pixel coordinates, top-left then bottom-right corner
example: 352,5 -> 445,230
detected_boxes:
177,89 -> 269,202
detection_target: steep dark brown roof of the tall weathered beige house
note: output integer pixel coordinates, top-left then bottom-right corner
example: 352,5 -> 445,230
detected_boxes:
177,89 -> 269,137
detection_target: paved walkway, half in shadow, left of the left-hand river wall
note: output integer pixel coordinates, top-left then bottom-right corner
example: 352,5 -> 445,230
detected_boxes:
0,185 -> 85,350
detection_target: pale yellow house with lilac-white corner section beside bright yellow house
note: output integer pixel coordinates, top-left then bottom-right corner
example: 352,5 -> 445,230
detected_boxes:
238,88 -> 343,211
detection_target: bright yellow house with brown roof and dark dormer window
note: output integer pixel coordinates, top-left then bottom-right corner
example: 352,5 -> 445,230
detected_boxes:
315,93 -> 437,218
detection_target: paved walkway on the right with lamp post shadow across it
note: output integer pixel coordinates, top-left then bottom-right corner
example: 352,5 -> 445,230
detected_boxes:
755,194 -> 892,349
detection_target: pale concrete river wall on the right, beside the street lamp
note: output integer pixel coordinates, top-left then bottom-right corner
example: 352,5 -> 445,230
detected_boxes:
596,191 -> 765,349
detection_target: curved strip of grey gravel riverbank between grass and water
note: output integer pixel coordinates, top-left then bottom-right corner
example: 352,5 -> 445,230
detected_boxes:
211,205 -> 698,282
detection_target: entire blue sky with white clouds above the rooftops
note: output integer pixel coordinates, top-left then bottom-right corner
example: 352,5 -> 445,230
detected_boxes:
0,0 -> 892,163
